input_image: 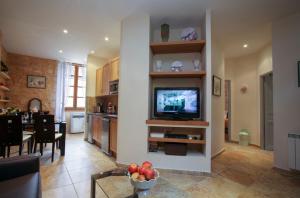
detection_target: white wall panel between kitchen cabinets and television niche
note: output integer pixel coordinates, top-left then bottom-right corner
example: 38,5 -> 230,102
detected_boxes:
117,15 -> 150,164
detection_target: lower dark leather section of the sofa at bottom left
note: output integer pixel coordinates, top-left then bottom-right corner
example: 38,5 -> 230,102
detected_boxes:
0,173 -> 41,198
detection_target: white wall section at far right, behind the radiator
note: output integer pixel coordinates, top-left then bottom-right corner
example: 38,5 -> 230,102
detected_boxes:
272,13 -> 300,169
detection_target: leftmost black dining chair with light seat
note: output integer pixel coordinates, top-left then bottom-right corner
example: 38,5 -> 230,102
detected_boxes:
0,115 -> 31,157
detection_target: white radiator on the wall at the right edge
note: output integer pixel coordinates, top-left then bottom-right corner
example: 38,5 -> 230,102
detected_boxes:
288,133 -> 300,170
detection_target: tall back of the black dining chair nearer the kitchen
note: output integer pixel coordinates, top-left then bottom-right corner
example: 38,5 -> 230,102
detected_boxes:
34,115 -> 55,143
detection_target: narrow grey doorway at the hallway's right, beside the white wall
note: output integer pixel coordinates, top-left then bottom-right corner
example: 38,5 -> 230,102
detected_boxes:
261,73 -> 273,151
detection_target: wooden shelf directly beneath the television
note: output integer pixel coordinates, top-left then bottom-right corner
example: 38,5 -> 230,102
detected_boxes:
146,119 -> 209,128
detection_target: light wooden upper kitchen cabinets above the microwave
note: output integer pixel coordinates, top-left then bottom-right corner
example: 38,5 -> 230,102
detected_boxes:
96,57 -> 120,96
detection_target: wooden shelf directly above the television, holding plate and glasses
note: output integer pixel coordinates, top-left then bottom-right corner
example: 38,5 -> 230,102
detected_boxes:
149,71 -> 206,78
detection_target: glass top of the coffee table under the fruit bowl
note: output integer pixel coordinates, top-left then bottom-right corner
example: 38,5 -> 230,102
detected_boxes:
96,176 -> 188,198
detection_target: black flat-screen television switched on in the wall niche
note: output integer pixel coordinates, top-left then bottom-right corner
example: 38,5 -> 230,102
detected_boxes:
154,87 -> 200,119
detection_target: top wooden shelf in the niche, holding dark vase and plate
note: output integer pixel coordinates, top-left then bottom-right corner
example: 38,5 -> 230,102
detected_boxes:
150,40 -> 205,54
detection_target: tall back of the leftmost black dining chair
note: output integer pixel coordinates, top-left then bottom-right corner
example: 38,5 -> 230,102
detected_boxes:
0,115 -> 23,145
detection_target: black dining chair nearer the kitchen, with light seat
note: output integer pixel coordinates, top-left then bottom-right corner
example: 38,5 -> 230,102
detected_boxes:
34,115 -> 62,162
